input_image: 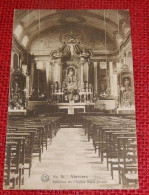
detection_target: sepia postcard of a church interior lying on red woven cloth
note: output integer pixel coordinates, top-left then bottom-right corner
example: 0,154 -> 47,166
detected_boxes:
4,10 -> 138,189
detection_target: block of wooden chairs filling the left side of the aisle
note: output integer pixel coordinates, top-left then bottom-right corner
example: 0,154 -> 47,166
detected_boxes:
4,116 -> 60,189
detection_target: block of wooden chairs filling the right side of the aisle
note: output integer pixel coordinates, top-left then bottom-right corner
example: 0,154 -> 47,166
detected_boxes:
83,116 -> 138,188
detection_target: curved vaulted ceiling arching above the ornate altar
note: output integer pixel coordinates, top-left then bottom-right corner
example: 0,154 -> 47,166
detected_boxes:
13,10 -> 130,54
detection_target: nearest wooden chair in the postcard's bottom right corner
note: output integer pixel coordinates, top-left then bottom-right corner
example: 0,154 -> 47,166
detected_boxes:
117,137 -> 138,187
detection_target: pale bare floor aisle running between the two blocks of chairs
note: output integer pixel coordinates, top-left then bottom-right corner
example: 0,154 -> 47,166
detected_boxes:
22,128 -> 121,189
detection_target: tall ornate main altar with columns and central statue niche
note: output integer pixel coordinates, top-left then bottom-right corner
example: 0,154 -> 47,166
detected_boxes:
46,31 -> 94,114
